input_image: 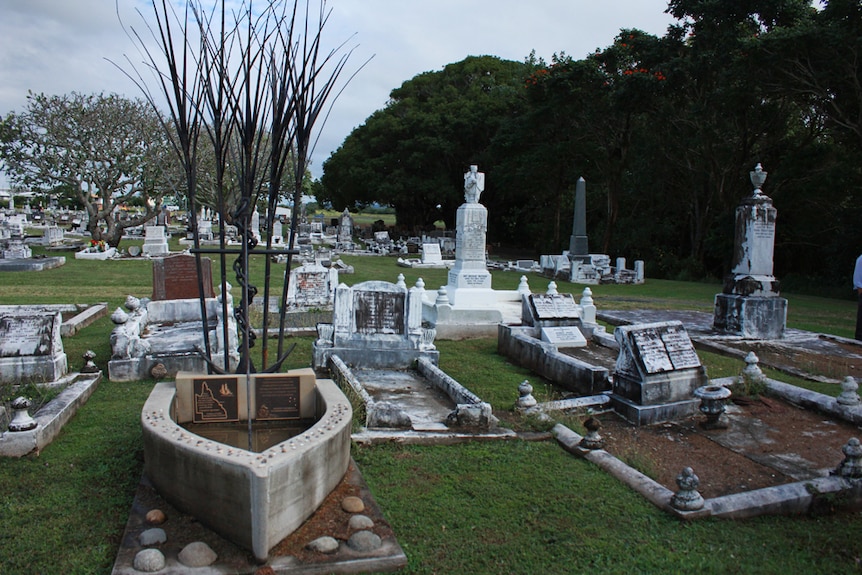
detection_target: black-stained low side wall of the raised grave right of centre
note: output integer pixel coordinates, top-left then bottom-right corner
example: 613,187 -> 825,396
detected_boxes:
497,325 -> 611,395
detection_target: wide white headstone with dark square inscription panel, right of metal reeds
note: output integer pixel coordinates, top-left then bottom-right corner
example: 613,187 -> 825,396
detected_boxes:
313,281 -> 439,369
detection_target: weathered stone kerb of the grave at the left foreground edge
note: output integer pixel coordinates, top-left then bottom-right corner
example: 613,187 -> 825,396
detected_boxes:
0,372 -> 102,457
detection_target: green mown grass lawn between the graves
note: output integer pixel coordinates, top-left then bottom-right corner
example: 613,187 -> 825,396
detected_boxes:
0,252 -> 862,575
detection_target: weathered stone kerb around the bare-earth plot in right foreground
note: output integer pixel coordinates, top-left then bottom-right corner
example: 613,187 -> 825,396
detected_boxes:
551,377 -> 862,519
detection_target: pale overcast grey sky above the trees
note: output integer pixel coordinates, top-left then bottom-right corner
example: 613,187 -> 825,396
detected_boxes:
0,0 -> 673,187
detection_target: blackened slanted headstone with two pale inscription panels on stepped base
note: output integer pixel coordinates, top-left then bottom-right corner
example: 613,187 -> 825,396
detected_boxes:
611,321 -> 708,425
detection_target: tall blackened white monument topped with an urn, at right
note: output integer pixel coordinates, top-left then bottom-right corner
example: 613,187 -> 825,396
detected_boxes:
713,164 -> 787,339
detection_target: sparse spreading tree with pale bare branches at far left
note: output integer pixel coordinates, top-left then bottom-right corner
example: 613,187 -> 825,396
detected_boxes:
0,92 -> 180,247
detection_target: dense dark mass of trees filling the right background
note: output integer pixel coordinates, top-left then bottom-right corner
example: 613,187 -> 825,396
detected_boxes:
318,0 -> 862,283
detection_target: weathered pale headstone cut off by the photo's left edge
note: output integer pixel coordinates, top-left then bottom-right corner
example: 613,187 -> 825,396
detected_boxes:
0,312 -> 68,384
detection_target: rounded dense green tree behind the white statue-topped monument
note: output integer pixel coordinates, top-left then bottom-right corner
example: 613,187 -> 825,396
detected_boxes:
318,56 -> 525,230
